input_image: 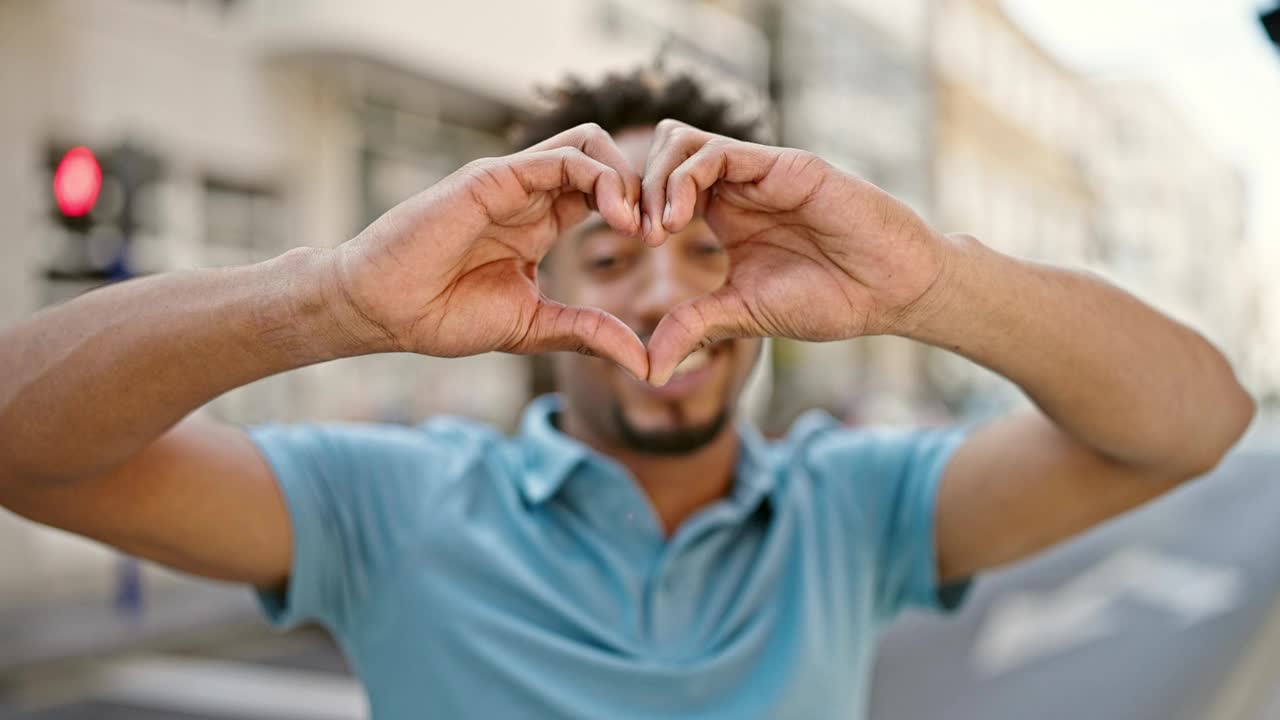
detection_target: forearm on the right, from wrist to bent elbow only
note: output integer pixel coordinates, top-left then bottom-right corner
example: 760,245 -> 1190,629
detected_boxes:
904,236 -> 1253,475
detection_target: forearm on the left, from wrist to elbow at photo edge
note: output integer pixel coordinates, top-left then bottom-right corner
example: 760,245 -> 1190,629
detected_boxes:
0,243 -> 372,482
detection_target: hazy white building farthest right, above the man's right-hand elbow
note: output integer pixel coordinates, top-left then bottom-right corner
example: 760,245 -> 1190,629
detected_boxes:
1089,82 -> 1263,369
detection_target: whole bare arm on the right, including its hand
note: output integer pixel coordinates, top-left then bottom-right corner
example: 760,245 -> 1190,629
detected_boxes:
641,120 -> 1253,579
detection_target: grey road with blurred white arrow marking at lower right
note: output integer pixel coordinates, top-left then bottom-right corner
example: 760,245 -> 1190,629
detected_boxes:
872,450 -> 1280,720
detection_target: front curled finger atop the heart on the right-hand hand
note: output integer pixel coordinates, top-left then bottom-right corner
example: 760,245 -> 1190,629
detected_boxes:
663,140 -> 780,233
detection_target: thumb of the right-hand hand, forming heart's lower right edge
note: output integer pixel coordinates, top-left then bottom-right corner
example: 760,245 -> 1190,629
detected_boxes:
649,287 -> 762,386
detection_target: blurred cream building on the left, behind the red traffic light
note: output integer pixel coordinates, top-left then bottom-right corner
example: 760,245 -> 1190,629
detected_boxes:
0,0 -> 768,609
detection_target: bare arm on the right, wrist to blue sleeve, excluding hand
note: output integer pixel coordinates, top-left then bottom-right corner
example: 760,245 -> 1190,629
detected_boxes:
904,236 -> 1254,578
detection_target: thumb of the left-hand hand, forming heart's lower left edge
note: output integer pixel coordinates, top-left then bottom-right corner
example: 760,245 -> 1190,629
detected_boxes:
520,299 -> 649,379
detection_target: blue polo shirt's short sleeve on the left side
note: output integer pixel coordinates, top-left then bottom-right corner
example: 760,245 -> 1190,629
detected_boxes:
248,424 -> 438,630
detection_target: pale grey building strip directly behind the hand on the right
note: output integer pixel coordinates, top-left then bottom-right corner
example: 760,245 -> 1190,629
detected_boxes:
774,0 -> 933,423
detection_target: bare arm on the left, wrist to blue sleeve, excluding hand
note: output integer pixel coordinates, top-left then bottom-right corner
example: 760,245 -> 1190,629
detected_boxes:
0,249 -> 366,584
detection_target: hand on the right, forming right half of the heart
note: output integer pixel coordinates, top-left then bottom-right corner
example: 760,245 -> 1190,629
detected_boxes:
641,120 -> 946,386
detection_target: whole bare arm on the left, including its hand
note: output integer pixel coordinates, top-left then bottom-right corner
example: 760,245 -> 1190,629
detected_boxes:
0,126 -> 648,587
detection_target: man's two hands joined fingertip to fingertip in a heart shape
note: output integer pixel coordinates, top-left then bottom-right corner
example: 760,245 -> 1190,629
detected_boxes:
335,120 -> 945,384
